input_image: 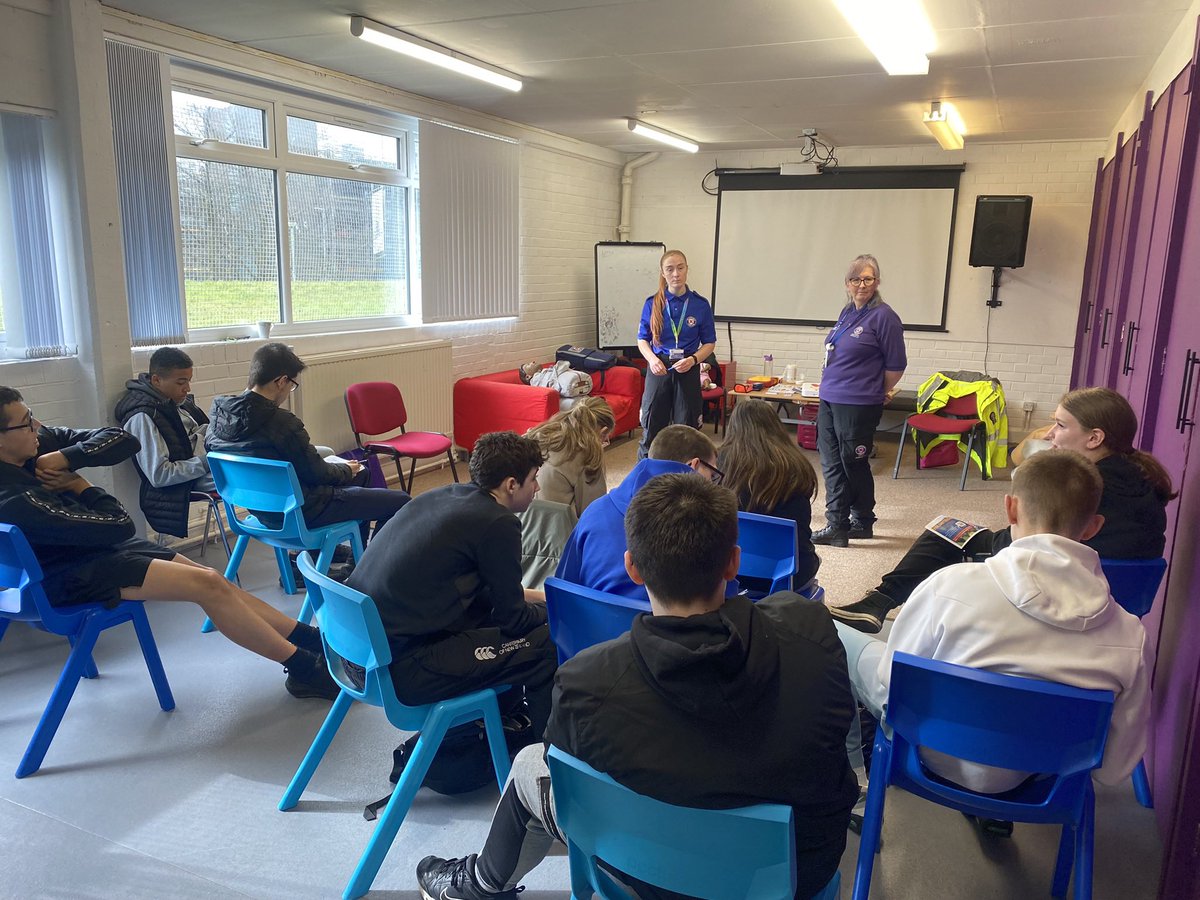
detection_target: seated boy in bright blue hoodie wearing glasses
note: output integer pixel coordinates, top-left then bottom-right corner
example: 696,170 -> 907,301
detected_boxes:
556,425 -> 720,600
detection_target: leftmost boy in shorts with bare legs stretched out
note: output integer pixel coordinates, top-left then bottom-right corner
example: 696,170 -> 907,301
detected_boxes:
0,388 -> 338,700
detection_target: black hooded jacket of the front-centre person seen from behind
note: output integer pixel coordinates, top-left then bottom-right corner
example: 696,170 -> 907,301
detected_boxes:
546,592 -> 858,898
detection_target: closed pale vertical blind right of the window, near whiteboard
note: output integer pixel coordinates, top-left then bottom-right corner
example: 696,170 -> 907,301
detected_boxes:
420,121 -> 521,322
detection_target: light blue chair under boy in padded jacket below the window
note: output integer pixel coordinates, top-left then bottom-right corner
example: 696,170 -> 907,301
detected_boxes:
200,452 -> 362,632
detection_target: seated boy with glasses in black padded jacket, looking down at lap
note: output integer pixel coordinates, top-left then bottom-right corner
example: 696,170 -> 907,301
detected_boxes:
204,343 -> 408,544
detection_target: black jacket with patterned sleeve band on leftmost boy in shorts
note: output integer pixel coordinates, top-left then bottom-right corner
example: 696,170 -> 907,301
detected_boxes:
0,426 -> 139,574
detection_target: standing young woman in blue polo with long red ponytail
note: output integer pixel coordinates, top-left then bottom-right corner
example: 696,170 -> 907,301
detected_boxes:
637,250 -> 716,460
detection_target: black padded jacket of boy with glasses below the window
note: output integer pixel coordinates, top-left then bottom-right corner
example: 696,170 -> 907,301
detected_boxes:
204,391 -> 352,522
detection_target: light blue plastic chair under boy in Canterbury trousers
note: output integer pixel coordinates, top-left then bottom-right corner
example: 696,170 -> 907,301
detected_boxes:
280,553 -> 510,900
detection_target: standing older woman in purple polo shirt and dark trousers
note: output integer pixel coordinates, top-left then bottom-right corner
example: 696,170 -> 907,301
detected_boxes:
812,254 -> 908,547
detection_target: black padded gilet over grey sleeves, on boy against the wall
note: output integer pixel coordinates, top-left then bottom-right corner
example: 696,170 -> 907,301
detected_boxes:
114,372 -> 209,538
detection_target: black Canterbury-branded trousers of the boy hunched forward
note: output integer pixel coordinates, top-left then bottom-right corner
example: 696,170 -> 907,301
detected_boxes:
390,625 -> 558,740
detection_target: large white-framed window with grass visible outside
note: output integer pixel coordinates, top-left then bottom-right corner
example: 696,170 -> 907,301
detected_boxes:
172,70 -> 418,340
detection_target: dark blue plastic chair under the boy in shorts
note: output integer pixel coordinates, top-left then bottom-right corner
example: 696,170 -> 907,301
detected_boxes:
0,523 -> 175,778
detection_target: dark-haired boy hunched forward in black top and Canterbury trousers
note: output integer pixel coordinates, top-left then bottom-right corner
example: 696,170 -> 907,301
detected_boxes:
347,431 -> 557,737
